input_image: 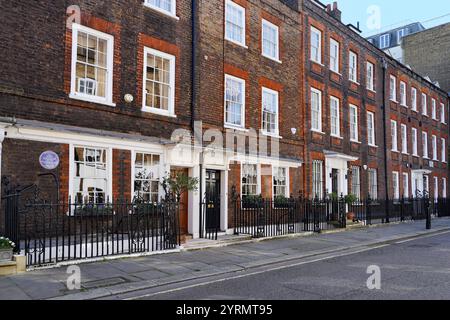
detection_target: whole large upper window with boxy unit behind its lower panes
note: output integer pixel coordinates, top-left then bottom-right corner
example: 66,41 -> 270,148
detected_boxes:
70,23 -> 114,104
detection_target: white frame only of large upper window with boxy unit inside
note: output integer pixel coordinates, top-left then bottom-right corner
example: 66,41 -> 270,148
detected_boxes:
69,23 -> 116,107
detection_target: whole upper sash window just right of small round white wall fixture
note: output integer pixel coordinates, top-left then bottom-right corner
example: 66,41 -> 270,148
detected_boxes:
143,48 -> 175,115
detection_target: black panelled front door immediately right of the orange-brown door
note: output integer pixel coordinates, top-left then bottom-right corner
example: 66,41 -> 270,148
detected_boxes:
205,170 -> 220,232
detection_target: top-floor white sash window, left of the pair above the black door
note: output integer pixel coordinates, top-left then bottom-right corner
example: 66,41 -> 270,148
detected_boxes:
225,0 -> 245,46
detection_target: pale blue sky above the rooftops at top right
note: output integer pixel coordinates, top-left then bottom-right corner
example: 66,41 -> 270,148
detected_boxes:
322,0 -> 450,36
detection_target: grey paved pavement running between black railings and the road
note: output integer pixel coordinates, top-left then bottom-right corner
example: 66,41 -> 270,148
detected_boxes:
0,218 -> 450,300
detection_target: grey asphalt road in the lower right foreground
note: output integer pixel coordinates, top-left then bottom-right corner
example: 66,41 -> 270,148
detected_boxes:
130,232 -> 450,300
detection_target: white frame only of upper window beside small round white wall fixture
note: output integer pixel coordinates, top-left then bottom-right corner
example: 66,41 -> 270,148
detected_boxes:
142,47 -> 176,117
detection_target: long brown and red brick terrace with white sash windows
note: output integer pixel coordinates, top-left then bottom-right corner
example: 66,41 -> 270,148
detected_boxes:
0,0 -> 449,237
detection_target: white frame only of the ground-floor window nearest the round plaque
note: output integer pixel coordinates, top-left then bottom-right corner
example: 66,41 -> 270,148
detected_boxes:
69,144 -> 113,203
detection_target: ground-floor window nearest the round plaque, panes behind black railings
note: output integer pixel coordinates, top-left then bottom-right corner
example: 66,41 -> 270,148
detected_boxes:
73,147 -> 110,204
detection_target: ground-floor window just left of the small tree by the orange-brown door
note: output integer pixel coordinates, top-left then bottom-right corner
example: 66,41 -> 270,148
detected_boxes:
133,152 -> 160,202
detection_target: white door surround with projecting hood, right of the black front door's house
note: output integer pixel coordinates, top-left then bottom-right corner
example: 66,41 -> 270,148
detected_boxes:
324,151 -> 358,196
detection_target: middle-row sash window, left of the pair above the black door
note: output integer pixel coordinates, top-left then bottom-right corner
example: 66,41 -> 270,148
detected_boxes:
225,75 -> 245,128
